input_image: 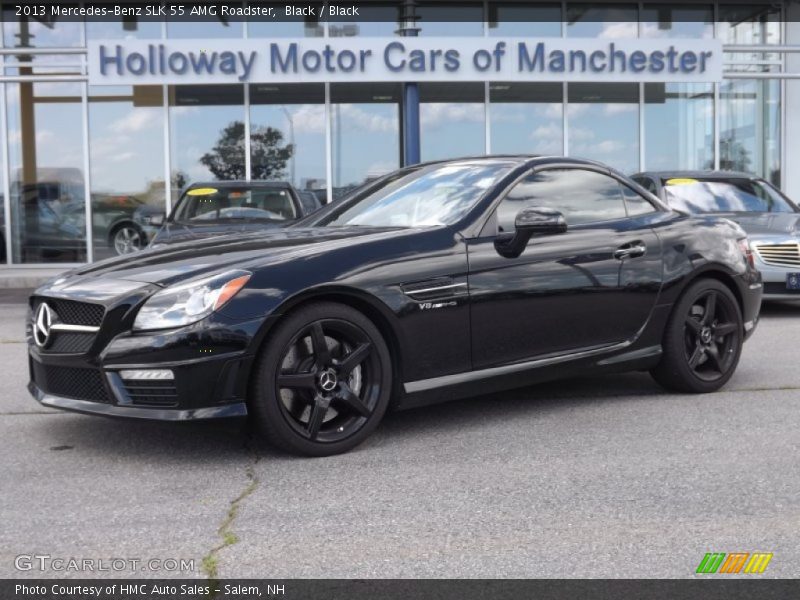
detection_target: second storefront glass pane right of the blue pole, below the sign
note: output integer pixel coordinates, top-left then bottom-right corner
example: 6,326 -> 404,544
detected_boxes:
489,83 -> 564,155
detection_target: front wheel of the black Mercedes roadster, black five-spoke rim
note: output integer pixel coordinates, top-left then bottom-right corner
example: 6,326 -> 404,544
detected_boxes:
249,302 -> 392,456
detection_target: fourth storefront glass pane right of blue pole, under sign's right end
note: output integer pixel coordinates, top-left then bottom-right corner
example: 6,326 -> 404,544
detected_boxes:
644,83 -> 714,170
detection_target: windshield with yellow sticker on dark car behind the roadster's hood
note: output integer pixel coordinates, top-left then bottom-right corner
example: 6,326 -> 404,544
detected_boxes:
175,187 -> 297,224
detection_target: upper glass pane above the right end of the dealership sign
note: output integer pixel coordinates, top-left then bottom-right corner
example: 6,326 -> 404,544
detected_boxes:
640,4 -> 714,39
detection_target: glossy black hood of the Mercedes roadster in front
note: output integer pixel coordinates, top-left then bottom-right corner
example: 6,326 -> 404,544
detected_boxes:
59,227 -> 415,286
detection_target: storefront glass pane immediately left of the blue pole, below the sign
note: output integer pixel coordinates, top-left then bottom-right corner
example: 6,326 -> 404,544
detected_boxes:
331,83 -> 400,200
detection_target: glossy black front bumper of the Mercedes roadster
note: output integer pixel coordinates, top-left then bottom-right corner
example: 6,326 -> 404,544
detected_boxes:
28,315 -> 263,421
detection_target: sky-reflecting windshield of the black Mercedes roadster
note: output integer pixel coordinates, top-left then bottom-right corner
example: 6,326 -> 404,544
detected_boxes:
320,161 -> 514,227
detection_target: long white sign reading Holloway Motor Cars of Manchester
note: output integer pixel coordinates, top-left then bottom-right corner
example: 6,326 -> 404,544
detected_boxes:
89,37 -> 722,85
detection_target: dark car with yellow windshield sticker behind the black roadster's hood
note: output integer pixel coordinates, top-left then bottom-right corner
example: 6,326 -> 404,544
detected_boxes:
151,181 -> 310,247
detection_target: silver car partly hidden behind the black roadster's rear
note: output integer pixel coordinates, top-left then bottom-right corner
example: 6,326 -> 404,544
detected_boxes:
632,171 -> 800,300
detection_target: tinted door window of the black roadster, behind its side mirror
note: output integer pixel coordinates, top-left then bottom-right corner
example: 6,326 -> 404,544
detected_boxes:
497,169 -> 628,232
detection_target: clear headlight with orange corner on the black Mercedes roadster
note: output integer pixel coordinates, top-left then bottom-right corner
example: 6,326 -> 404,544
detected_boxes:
133,270 -> 252,331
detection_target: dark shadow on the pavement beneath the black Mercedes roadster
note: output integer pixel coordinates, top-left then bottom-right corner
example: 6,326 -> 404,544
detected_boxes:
28,373 -> 720,458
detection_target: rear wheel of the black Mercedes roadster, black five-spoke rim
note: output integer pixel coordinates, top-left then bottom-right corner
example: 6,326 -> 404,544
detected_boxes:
650,279 -> 744,394
